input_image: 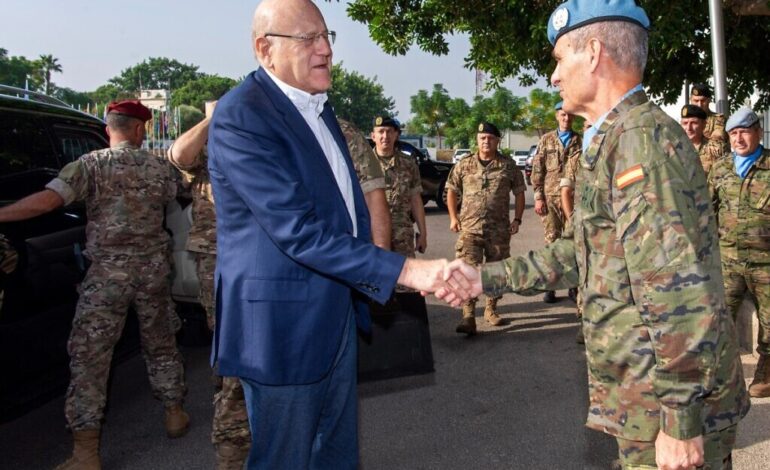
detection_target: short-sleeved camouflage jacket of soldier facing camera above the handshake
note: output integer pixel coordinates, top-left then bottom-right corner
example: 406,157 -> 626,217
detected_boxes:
446,152 -> 524,235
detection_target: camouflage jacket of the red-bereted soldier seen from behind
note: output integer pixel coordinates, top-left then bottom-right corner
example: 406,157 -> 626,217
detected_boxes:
46,142 -> 183,260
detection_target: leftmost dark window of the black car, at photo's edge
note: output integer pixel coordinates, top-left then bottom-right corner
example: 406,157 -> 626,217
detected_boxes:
0,111 -> 58,175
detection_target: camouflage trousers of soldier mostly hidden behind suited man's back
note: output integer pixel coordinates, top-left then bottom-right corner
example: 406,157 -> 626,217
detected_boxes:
195,252 -> 251,450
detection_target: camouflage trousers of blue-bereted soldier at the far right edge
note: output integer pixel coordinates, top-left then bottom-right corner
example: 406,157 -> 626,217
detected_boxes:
722,260 -> 770,356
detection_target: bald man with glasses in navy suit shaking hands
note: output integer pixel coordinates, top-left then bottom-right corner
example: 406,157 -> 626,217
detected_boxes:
209,0 -> 470,469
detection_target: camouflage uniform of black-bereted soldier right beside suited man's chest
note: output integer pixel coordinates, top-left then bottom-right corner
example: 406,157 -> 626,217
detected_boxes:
377,151 -> 422,258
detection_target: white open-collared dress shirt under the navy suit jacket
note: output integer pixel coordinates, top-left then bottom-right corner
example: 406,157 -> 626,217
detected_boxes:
263,67 -> 358,235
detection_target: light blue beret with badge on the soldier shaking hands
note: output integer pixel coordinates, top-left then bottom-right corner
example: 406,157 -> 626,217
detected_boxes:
548,0 -> 650,46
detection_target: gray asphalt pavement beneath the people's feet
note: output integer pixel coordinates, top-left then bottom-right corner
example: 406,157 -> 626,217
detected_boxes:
0,185 -> 770,470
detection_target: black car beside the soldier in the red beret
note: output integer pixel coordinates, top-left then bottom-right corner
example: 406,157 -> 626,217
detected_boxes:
0,85 -> 205,422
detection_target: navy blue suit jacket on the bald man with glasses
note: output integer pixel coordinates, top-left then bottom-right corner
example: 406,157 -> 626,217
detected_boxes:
208,69 -> 404,385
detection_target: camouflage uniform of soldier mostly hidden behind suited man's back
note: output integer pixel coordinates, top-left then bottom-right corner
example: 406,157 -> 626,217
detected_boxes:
176,150 -> 251,450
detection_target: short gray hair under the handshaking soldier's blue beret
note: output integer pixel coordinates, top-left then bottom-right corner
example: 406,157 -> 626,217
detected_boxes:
567,21 -> 648,76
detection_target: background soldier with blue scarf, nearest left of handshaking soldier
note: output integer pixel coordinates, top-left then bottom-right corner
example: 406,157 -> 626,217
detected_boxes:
531,102 -> 583,304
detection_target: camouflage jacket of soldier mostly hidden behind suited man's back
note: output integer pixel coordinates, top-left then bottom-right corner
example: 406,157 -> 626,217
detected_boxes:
171,148 -> 217,255
